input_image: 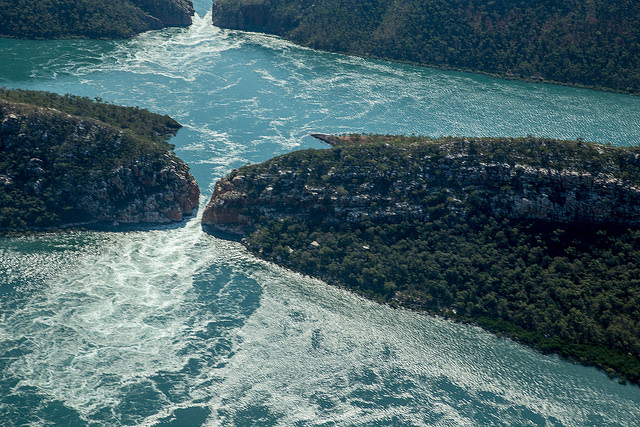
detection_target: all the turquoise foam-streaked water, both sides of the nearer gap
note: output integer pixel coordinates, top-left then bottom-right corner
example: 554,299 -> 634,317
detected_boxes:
0,1 -> 640,426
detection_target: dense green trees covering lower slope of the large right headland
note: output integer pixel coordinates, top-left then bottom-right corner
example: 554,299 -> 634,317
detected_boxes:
247,216 -> 640,383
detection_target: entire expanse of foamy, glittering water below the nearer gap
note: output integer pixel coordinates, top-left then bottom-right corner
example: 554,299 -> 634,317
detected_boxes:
0,210 -> 640,426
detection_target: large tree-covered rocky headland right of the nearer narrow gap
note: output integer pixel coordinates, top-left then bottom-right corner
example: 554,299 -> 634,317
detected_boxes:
202,134 -> 640,383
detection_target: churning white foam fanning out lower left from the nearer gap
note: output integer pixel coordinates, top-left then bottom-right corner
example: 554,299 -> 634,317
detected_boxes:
2,199 -> 245,421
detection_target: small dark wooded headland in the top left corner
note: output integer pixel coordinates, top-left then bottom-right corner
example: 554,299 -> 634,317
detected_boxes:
0,0 -> 194,39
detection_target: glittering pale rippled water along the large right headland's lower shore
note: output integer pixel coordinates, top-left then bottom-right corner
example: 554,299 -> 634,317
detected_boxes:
201,266 -> 640,426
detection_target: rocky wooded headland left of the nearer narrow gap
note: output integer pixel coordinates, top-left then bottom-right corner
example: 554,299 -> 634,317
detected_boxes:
0,89 -> 200,231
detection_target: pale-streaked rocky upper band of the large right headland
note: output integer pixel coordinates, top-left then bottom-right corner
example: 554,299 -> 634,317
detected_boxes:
203,136 -> 640,234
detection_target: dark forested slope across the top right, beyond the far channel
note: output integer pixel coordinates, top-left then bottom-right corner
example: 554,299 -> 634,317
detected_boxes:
213,0 -> 640,93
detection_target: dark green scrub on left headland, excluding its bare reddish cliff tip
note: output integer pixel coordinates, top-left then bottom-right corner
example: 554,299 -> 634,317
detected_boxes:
0,89 -> 180,230
